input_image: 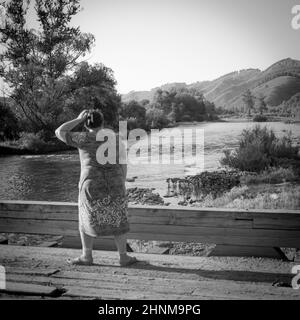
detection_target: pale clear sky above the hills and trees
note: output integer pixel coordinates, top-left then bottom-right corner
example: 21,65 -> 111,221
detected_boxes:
1,0 -> 300,93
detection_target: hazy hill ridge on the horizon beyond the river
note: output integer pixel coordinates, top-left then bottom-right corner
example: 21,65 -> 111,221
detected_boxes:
122,58 -> 300,109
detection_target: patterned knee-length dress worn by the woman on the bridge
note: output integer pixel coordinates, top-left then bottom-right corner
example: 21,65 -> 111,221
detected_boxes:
66,132 -> 129,237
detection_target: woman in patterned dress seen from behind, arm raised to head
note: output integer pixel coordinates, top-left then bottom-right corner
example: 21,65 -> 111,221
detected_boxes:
55,110 -> 137,266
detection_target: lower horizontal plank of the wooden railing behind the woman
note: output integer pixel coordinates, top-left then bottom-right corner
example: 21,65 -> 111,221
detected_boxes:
0,219 -> 300,248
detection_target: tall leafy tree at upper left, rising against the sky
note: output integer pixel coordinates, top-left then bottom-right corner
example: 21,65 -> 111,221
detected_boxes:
0,0 -> 94,132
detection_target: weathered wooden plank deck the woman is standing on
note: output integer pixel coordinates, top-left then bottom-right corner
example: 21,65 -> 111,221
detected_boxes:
0,245 -> 300,300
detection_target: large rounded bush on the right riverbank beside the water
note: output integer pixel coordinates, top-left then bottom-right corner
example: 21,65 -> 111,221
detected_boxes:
221,126 -> 298,172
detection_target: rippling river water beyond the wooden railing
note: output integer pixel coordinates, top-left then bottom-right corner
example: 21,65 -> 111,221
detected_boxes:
0,122 -> 300,201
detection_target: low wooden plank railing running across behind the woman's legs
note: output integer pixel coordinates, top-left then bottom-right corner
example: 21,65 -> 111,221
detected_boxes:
0,201 -> 300,258
